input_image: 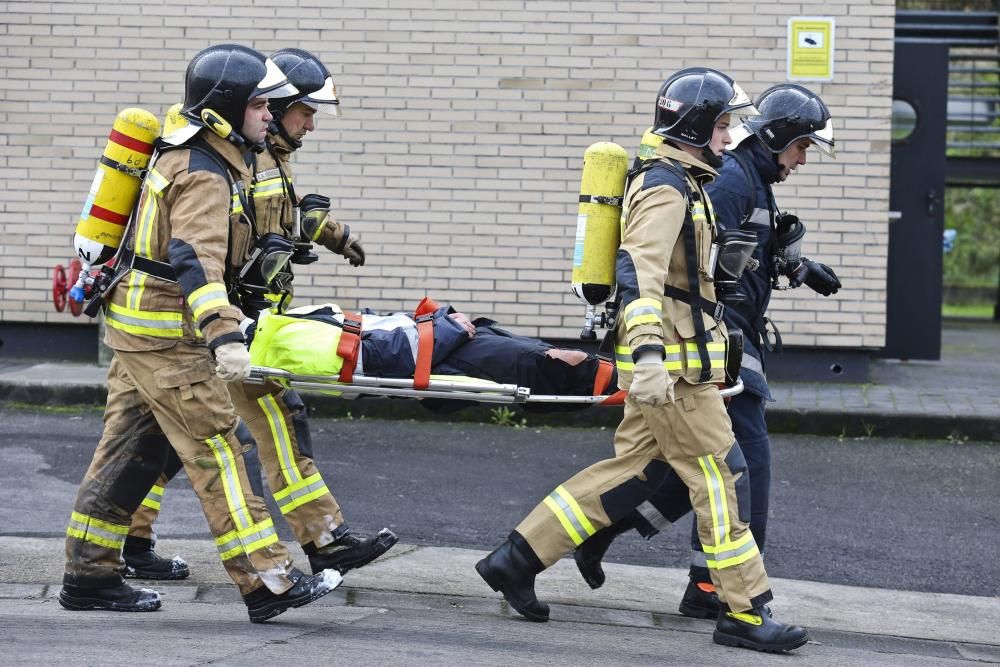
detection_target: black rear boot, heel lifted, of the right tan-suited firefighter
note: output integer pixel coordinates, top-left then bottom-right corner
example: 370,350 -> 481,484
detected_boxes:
476,532 -> 549,623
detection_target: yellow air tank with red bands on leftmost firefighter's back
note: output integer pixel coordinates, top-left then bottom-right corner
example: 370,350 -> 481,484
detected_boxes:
73,107 -> 160,269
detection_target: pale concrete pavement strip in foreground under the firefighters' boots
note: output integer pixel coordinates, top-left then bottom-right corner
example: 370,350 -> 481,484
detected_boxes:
0,537 -> 1000,665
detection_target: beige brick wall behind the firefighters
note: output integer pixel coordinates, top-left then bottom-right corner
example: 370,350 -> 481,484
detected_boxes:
0,0 -> 894,347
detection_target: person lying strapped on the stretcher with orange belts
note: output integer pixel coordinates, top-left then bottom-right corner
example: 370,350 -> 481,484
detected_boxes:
250,299 -> 618,411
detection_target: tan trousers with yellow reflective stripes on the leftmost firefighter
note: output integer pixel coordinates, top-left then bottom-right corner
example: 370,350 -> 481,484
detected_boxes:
65,343 -> 292,595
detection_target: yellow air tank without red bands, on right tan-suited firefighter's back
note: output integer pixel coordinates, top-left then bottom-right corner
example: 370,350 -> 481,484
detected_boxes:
572,141 -> 628,305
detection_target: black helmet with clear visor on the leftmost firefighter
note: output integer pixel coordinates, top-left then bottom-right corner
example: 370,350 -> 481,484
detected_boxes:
181,44 -> 295,144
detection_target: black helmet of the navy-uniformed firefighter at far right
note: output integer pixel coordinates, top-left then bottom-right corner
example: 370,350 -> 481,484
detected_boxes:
733,83 -> 836,157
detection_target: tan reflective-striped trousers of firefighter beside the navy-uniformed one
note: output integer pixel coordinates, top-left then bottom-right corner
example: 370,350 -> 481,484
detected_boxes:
516,379 -> 771,612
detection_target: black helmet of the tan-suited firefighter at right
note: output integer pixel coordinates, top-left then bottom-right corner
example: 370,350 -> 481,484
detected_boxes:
653,67 -> 757,148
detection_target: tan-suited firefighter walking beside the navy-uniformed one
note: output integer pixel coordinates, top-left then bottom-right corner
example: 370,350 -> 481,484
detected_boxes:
476,67 -> 808,652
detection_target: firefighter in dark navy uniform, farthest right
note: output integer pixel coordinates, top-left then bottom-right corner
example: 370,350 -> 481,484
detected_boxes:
574,83 -> 841,619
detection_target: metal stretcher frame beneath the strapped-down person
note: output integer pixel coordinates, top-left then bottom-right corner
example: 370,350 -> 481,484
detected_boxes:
247,366 -> 743,406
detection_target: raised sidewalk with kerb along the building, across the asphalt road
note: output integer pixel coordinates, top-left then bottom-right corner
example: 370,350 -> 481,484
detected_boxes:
0,321 -> 1000,441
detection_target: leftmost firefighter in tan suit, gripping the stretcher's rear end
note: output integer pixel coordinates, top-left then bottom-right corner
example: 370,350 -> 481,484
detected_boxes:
59,44 -> 341,622
